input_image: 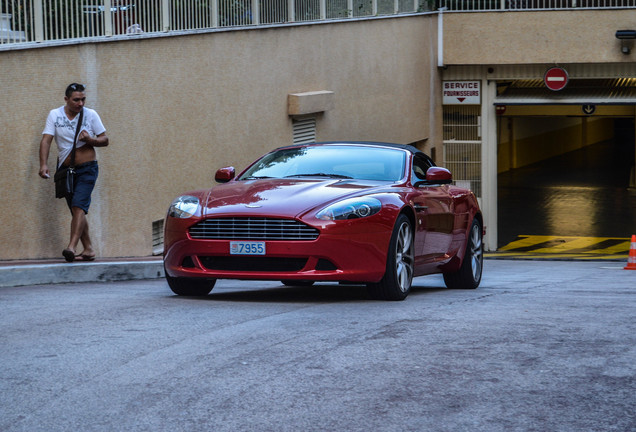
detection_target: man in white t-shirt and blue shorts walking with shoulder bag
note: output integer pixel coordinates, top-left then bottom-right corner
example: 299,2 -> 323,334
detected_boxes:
39,83 -> 108,262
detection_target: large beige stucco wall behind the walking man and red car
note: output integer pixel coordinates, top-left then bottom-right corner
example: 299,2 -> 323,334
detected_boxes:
0,15 -> 441,260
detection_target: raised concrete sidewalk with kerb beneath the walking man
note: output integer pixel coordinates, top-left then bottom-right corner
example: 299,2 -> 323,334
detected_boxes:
0,256 -> 164,287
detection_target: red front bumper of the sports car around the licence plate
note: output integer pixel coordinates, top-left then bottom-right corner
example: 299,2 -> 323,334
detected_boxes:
164,219 -> 391,282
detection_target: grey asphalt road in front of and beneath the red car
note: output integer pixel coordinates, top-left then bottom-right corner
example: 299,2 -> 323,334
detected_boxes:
0,260 -> 636,432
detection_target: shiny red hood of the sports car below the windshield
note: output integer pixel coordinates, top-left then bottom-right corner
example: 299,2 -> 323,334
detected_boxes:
202,179 -> 387,217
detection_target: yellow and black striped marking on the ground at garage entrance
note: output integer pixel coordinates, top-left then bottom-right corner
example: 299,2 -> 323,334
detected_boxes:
485,235 -> 631,260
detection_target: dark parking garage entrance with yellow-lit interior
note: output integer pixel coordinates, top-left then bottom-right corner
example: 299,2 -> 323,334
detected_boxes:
496,80 -> 636,256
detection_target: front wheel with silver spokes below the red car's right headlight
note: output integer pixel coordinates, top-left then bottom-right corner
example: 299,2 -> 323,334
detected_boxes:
368,214 -> 415,300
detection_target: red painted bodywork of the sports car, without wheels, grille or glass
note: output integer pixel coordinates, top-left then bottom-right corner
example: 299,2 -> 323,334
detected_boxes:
164,142 -> 480,283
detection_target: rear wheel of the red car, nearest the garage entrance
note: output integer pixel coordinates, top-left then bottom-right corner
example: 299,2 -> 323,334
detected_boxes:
444,219 -> 484,289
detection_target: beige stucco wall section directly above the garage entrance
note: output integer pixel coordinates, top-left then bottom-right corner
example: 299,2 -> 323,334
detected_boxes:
443,9 -> 636,65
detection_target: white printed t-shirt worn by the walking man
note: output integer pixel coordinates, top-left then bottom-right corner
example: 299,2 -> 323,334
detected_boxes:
42,105 -> 106,167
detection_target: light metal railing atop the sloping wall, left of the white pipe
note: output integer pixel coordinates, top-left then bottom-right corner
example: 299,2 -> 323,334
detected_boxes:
0,0 -> 430,46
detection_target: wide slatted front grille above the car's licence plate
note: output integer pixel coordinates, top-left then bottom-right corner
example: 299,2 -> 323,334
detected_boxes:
190,218 -> 319,240
